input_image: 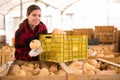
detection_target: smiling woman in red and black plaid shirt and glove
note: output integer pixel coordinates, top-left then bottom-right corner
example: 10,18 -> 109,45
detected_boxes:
14,5 -> 47,61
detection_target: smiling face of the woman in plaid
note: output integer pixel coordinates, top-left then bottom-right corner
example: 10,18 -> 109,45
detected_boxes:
27,10 -> 41,27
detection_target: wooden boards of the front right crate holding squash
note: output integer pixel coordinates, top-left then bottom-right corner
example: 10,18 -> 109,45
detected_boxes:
61,59 -> 120,80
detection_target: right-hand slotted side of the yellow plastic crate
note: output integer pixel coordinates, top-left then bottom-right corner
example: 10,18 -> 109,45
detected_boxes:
68,35 -> 88,60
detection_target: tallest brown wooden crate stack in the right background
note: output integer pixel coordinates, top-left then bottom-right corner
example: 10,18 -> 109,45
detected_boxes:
94,26 -> 115,43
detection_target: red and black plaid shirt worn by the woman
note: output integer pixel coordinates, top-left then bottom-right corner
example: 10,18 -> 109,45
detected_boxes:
14,19 -> 47,61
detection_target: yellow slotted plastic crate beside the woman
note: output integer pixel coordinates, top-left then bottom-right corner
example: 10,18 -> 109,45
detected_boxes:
39,34 -> 88,63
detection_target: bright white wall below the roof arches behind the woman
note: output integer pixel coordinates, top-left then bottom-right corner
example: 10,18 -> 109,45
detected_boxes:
1,0 -> 120,45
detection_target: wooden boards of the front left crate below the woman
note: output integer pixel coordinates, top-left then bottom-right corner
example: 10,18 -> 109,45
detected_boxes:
0,60 -> 69,80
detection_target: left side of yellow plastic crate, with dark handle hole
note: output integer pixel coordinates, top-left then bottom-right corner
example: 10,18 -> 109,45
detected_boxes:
40,35 -> 70,62
